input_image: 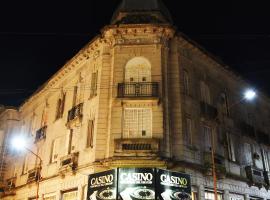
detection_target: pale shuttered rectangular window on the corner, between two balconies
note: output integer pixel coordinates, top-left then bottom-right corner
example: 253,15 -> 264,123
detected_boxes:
124,108 -> 152,138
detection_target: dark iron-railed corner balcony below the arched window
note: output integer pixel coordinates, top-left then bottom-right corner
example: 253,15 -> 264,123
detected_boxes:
117,82 -> 159,98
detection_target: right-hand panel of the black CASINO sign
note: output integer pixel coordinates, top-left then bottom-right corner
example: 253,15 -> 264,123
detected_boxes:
156,169 -> 191,200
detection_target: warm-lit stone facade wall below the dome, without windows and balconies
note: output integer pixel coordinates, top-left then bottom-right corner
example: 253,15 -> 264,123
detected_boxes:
0,25 -> 270,200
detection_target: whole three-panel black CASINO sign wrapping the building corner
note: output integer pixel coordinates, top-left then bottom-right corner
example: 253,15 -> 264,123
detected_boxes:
87,168 -> 191,200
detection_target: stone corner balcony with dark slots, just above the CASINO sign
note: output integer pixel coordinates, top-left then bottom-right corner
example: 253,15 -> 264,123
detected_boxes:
114,138 -> 159,156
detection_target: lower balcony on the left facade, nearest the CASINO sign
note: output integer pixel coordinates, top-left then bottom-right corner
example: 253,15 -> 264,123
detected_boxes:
59,152 -> 79,174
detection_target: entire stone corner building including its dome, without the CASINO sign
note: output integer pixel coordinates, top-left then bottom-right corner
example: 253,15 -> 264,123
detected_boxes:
0,0 -> 270,200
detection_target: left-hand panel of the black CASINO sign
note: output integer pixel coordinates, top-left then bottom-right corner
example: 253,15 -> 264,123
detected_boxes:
87,170 -> 117,200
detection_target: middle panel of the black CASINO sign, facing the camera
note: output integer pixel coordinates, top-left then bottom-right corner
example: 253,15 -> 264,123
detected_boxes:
118,168 -> 155,200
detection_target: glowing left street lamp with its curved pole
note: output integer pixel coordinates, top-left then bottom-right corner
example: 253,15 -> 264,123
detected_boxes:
11,136 -> 42,200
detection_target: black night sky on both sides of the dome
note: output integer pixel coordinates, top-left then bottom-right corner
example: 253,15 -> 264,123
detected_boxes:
0,0 -> 270,106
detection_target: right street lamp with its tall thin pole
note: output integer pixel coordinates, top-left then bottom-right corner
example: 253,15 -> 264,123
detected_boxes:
211,89 -> 257,200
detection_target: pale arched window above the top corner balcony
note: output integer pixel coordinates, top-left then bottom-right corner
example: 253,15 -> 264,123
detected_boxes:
125,57 -> 151,82
